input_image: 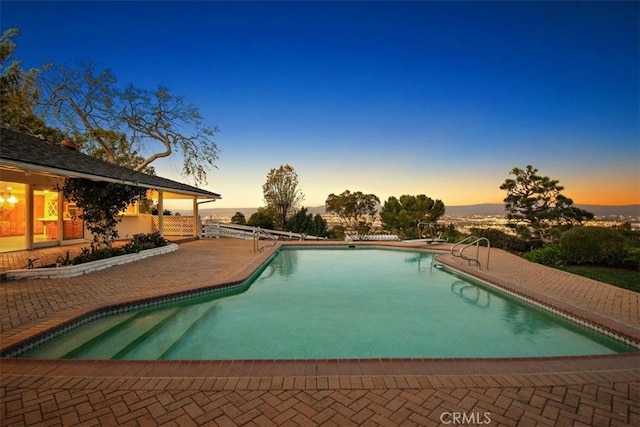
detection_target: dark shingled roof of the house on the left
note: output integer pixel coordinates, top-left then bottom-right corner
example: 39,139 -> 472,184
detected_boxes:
0,128 -> 220,199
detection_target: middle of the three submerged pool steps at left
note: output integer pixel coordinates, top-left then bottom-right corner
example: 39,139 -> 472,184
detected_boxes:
64,307 -> 180,359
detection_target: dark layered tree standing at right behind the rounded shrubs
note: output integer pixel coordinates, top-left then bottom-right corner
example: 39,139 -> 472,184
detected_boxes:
500,165 -> 593,241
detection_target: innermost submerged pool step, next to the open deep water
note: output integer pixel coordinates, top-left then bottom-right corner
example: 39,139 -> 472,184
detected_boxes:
118,301 -> 217,360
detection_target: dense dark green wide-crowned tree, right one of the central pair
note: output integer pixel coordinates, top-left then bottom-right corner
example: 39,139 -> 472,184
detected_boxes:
380,194 -> 445,239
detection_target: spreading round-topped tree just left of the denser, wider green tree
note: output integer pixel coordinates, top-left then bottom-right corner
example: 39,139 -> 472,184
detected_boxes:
324,190 -> 380,230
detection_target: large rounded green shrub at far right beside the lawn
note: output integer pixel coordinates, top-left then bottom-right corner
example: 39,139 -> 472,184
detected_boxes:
560,227 -> 626,266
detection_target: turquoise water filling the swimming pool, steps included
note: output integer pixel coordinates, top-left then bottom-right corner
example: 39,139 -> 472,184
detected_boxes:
23,248 -> 634,360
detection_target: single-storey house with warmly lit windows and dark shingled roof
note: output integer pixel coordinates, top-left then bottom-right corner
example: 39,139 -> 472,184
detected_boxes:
0,128 -> 221,252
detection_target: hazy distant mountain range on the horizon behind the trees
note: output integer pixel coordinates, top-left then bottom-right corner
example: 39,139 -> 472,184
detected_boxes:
200,203 -> 640,218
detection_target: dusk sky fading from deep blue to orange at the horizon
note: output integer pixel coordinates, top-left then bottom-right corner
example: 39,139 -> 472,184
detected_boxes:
0,1 -> 640,208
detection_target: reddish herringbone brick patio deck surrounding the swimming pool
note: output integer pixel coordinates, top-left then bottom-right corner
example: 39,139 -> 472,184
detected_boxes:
0,240 -> 640,426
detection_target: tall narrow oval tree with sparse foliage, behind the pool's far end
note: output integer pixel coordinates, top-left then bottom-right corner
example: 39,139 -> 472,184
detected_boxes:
262,165 -> 304,230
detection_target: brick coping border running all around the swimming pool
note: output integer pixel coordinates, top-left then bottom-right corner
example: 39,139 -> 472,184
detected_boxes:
0,241 -> 640,376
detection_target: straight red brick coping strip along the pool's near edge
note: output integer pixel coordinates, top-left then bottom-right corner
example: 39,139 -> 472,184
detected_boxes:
2,353 -> 640,378
